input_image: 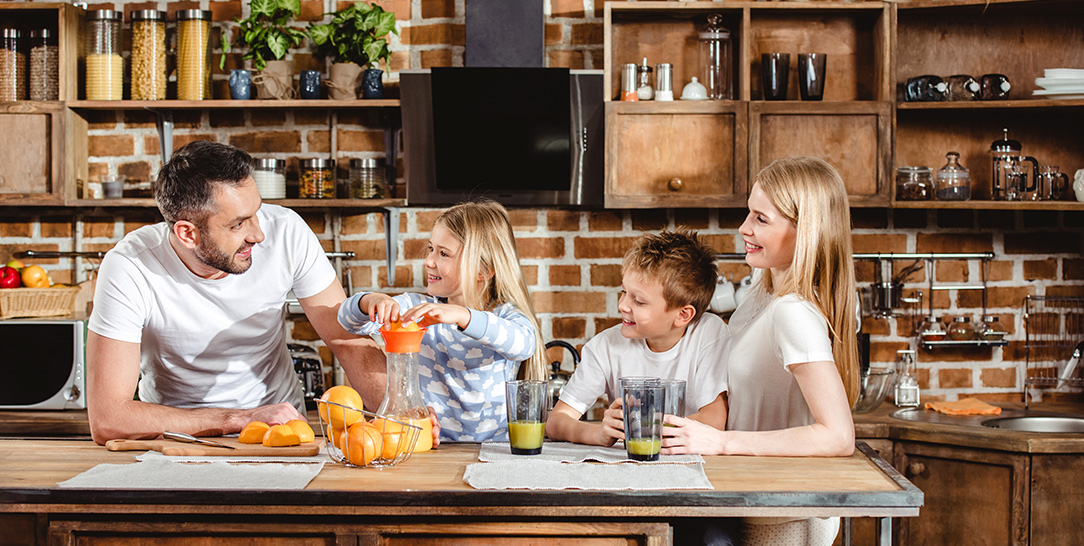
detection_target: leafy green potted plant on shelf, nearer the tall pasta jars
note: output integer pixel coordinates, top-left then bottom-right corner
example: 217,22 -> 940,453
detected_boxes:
219,0 -> 306,99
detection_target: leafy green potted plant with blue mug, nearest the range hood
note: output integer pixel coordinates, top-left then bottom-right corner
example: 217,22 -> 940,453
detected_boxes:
309,2 -> 399,99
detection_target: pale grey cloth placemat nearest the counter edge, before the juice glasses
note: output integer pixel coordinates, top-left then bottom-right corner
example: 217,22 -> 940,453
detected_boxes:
463,461 -> 714,491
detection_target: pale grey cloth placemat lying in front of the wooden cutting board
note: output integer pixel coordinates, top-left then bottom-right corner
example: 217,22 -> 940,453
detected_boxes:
57,457 -> 324,490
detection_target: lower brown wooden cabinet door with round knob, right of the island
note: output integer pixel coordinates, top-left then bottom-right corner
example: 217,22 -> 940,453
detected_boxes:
894,442 -> 1030,546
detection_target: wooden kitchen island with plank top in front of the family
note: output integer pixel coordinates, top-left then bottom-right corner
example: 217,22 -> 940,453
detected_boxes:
0,439 -> 922,546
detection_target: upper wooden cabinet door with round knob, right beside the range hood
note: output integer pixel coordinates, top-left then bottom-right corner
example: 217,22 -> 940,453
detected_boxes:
606,101 -> 747,208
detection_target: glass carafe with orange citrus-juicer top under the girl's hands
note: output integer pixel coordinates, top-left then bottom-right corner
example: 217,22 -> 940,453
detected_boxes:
376,328 -> 433,453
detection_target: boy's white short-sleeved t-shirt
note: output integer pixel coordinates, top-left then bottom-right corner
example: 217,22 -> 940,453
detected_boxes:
560,313 -> 731,415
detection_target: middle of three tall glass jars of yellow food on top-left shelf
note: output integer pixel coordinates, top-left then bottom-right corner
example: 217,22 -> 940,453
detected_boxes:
130,10 -> 166,101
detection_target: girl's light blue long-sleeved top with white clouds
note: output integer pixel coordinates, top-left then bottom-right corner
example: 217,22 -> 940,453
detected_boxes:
338,293 -> 535,442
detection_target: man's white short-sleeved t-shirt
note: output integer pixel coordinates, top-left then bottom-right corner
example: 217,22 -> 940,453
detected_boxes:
89,204 -> 335,411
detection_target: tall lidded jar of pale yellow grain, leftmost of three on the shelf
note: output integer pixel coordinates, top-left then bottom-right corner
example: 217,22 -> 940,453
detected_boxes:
83,10 -> 125,101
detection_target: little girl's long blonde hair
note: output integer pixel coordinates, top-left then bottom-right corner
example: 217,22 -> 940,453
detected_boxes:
436,199 -> 547,380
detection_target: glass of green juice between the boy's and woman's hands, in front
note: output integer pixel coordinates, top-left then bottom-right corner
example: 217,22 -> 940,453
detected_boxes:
621,380 -> 667,460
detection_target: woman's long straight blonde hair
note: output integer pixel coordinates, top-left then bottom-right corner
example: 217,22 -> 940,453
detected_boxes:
757,157 -> 859,406
